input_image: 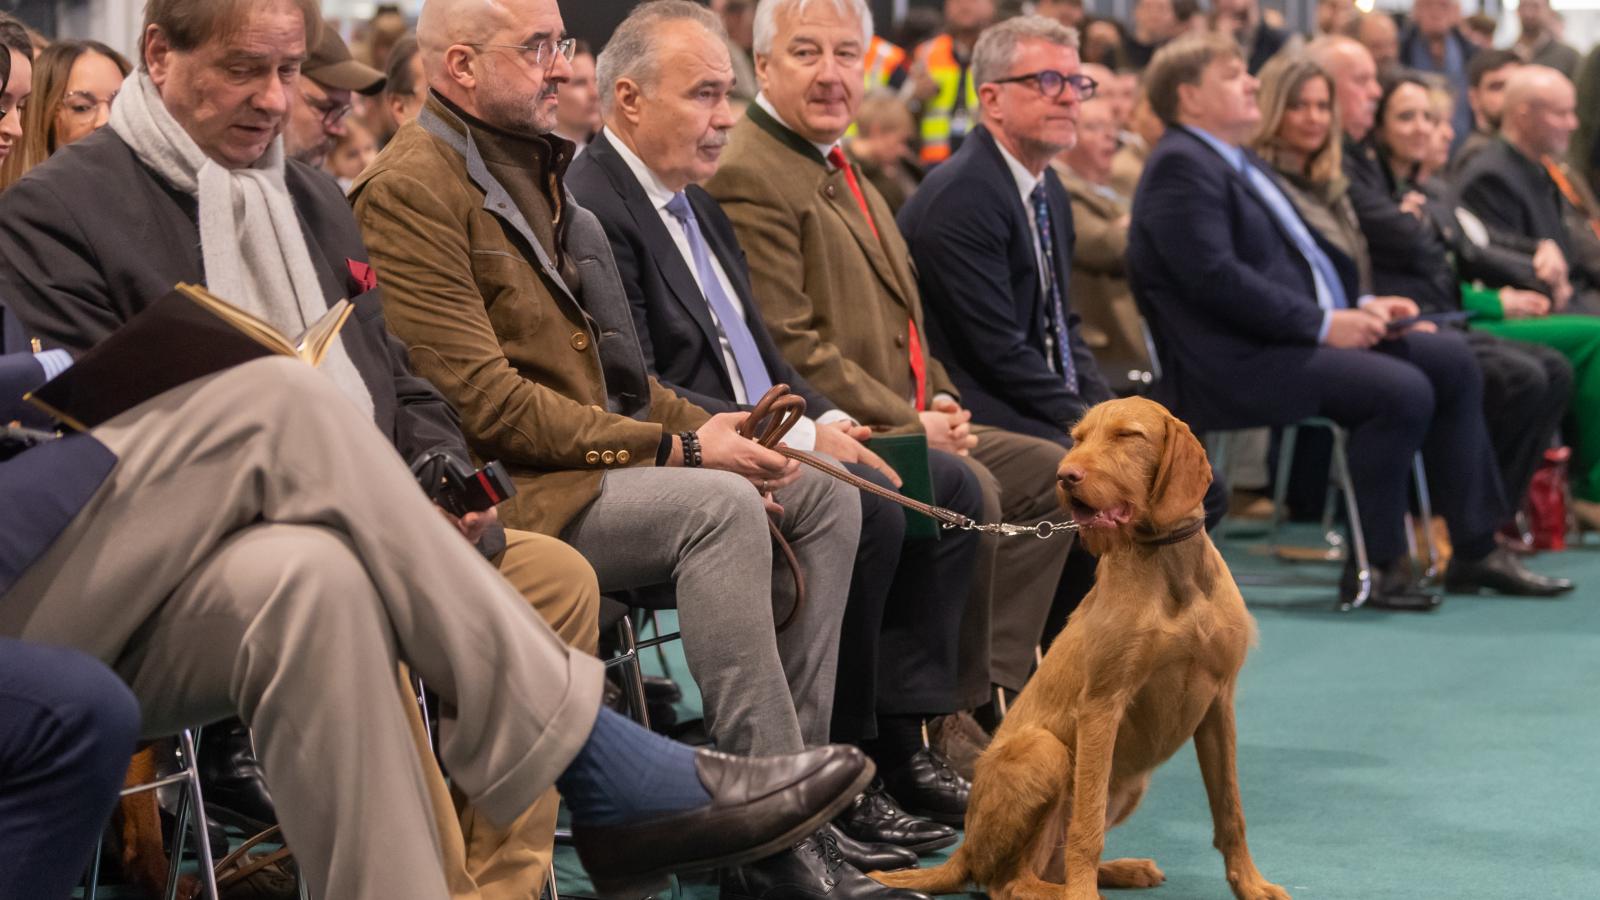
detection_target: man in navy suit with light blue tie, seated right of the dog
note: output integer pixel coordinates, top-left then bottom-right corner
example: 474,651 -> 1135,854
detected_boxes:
1128,35 -> 1570,610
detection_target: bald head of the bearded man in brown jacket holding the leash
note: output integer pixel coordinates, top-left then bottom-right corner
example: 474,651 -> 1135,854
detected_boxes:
416,0 -> 573,135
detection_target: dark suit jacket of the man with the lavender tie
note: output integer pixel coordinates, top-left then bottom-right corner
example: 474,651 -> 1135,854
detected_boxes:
566,135 -> 835,416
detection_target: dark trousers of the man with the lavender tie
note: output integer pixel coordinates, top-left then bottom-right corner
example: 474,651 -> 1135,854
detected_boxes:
830,450 -> 982,743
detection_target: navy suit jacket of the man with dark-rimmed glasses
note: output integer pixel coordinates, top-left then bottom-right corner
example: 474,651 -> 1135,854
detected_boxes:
899,127 -> 1112,440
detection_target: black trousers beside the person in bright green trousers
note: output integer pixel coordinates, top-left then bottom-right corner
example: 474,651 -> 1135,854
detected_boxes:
1467,331 -> 1573,509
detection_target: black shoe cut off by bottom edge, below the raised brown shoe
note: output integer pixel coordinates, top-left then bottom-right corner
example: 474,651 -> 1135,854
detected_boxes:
722,833 -> 931,900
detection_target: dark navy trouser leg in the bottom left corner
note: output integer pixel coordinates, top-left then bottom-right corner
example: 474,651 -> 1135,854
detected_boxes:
0,637 -> 139,900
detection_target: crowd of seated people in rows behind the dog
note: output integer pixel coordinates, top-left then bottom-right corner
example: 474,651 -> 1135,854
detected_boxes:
0,0 -> 1600,900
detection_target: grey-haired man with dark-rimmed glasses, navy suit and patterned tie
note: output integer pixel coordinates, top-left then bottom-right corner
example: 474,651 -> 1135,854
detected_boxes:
898,16 -> 1112,442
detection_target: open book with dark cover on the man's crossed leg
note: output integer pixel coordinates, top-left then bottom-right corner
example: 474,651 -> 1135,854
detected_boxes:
26,285 -> 354,431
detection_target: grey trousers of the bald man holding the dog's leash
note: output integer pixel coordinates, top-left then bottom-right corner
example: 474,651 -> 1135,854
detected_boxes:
562,458 -> 861,756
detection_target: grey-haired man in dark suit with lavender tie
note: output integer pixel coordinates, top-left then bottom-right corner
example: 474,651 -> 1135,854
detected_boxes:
566,3 -> 960,871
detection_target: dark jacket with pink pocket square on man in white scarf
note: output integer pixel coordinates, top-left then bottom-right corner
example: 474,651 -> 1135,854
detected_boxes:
0,128 -> 467,460
